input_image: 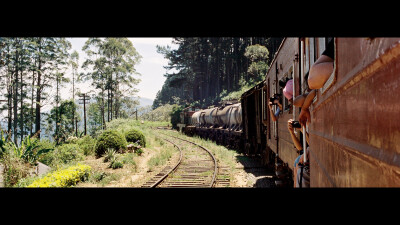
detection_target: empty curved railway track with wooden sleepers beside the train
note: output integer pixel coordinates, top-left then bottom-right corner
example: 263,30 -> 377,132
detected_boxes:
142,134 -> 222,188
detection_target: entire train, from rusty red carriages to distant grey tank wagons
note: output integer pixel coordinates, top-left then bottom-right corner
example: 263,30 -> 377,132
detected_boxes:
180,37 -> 400,187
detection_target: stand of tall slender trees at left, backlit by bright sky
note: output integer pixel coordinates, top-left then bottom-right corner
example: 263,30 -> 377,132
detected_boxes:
0,37 -> 141,143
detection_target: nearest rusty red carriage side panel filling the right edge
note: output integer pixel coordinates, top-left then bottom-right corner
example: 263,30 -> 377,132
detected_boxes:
309,38 -> 400,187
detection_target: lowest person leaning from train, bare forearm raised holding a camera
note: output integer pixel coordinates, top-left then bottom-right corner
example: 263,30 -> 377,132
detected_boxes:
288,119 -> 309,187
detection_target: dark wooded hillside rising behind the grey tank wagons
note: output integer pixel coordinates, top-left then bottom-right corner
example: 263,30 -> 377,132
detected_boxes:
153,37 -> 283,109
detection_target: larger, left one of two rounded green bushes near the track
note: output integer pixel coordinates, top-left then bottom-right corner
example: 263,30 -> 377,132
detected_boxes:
95,130 -> 128,157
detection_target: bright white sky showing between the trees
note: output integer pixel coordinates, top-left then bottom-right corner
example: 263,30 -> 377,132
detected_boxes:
62,37 -> 177,100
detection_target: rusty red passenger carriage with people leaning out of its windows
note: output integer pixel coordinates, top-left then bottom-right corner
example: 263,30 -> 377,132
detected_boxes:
265,38 -> 400,187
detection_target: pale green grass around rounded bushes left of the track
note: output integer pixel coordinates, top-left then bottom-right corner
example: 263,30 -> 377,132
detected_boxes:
3,119 -> 200,187
